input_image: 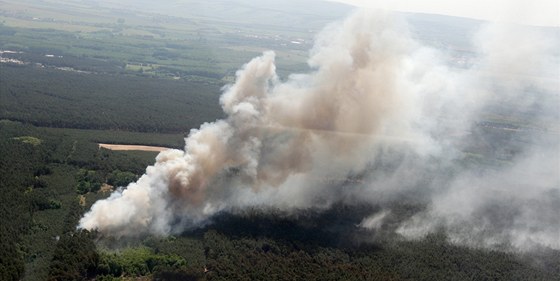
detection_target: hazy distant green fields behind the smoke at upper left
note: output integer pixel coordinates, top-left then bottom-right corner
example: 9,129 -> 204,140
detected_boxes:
0,1 -> 320,82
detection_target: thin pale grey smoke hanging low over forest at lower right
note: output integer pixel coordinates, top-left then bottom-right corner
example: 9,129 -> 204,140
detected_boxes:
397,147 -> 560,250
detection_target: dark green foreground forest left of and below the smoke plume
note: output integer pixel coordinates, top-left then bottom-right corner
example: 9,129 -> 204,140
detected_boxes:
0,120 -> 560,280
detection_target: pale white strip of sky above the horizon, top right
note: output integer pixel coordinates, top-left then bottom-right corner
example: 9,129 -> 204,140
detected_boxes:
332,0 -> 560,27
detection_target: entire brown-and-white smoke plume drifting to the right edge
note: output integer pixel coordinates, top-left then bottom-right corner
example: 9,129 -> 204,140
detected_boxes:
79,12 -> 560,250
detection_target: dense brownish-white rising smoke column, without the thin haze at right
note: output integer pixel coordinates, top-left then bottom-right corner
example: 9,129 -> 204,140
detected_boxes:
80,13 -> 416,236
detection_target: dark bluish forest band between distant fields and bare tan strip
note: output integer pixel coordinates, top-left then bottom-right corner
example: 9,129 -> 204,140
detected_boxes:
0,66 -> 222,133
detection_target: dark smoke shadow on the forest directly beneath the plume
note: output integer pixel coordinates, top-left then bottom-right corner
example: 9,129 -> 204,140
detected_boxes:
181,203 -> 423,249
